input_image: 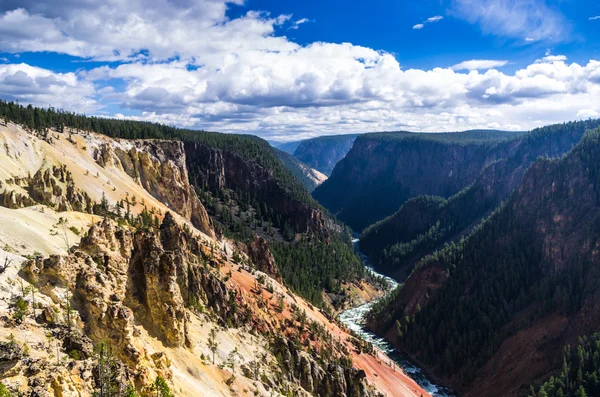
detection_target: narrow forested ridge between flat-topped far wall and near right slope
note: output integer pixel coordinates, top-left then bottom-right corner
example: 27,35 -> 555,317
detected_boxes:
360,120 -> 600,281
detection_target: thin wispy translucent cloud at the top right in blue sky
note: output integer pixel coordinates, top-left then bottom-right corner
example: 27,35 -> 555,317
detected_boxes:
451,0 -> 570,42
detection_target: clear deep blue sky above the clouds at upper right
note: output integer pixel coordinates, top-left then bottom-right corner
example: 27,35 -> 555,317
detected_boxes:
230,0 -> 600,70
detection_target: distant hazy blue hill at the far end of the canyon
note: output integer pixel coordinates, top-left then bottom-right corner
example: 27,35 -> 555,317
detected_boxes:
293,134 -> 358,175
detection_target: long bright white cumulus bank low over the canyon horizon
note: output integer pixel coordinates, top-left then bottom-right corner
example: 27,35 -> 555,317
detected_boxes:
76,53 -> 600,138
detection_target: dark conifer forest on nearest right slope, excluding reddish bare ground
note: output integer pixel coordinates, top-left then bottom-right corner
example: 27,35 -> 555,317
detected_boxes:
373,130 -> 600,384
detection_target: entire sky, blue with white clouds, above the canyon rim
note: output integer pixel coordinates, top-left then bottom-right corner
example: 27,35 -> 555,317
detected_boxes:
0,0 -> 600,140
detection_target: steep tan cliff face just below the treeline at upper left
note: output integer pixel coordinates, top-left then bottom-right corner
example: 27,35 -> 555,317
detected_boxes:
94,140 -> 214,236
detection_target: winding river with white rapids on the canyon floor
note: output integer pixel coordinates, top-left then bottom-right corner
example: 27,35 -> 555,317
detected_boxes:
339,239 -> 454,397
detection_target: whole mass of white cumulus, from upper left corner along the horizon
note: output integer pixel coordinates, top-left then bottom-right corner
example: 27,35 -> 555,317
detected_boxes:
0,0 -> 600,139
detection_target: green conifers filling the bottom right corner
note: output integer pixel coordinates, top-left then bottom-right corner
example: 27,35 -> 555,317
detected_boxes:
528,333 -> 600,397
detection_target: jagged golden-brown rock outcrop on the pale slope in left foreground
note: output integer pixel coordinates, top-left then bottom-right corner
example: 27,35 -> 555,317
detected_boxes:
23,213 -> 236,354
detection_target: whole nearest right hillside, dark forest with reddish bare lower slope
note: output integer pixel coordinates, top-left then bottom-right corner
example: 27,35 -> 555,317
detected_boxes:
371,129 -> 600,397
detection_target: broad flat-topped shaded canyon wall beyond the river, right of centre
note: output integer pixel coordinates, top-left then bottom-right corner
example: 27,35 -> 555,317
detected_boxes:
313,131 -> 523,231
